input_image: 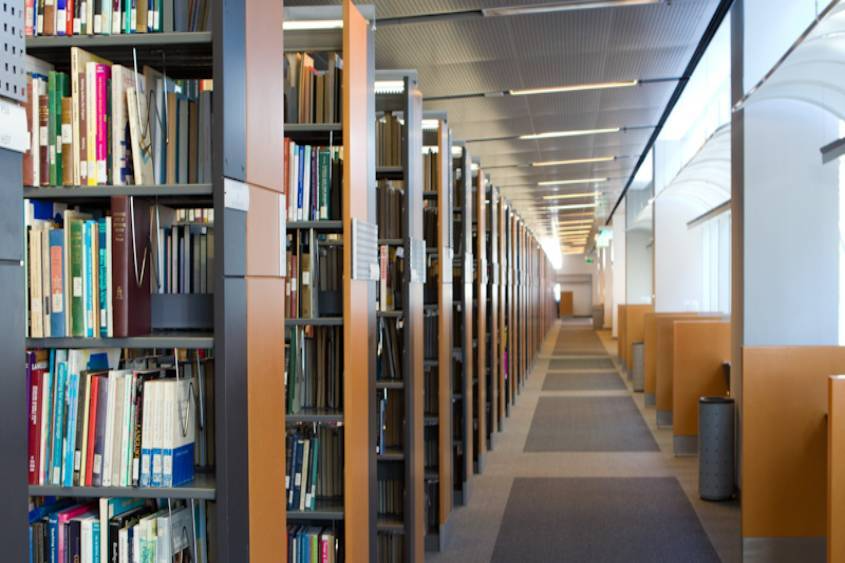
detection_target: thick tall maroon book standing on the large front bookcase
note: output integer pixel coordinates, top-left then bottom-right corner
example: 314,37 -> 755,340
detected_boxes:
111,196 -> 152,338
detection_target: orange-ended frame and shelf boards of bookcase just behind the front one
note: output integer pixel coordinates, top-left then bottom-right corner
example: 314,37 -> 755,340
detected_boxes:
284,0 -> 378,561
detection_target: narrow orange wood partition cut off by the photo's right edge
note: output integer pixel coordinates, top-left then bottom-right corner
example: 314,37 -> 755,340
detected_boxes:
827,375 -> 845,563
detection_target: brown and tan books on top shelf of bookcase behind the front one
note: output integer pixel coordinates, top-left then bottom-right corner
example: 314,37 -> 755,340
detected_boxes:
284,53 -> 343,123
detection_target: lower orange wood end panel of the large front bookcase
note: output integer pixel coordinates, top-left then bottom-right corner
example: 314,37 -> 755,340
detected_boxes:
246,277 -> 287,561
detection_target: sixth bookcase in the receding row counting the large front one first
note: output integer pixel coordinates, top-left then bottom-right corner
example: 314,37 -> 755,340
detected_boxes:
472,167 -> 495,458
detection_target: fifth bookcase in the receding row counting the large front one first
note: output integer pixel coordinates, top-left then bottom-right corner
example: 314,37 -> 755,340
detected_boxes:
451,143 -> 476,505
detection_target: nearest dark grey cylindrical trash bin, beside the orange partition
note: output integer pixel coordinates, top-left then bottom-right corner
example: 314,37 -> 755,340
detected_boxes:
698,397 -> 735,500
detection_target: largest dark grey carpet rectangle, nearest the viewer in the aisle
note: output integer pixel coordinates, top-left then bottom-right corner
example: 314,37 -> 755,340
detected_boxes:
492,477 -> 719,563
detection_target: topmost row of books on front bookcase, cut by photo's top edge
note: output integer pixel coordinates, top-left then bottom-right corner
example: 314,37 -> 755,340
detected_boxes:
24,0 -> 213,37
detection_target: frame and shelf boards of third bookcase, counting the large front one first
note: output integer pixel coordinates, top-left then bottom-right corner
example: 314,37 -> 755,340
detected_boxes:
372,70 -> 425,563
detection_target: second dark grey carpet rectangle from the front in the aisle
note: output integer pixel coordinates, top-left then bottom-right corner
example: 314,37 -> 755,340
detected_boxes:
525,397 -> 660,452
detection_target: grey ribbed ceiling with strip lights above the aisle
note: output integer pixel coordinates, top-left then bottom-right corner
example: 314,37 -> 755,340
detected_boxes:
285,0 -> 719,253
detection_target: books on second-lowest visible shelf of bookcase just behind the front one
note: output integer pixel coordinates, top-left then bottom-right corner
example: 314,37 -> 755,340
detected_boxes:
285,425 -> 343,511
